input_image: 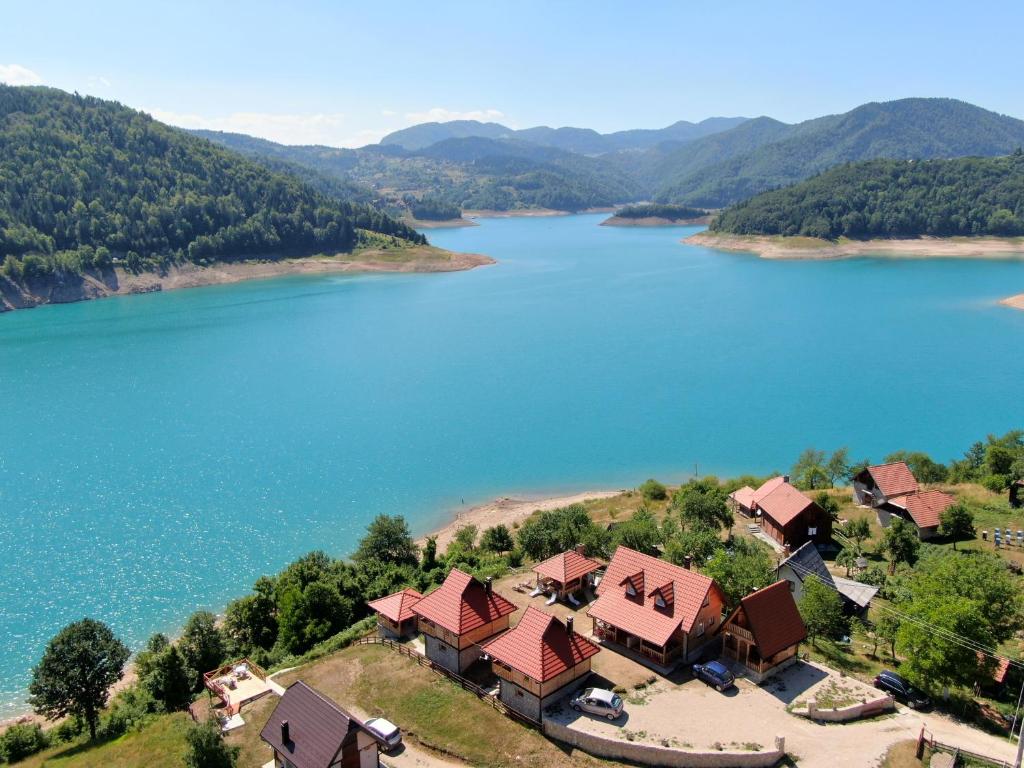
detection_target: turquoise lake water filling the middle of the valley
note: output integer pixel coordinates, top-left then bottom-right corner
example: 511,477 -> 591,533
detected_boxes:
0,216 -> 1024,717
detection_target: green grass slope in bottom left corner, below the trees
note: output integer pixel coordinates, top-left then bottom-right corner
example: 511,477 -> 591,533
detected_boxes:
17,713 -> 191,768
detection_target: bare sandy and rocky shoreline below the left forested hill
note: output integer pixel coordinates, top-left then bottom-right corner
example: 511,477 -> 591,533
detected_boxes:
0,246 -> 495,312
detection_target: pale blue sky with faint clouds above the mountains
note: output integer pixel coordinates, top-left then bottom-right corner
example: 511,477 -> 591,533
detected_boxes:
0,0 -> 1024,146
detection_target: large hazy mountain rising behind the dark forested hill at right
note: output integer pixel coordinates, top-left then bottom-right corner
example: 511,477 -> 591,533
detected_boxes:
644,98 -> 1024,207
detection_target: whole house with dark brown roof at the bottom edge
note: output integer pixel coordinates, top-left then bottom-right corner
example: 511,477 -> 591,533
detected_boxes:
259,680 -> 380,768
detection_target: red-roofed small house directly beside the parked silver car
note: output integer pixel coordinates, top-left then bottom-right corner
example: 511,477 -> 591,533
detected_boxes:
483,606 -> 600,721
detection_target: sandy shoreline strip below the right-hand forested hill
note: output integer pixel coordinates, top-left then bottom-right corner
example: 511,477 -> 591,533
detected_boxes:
683,230 -> 1024,260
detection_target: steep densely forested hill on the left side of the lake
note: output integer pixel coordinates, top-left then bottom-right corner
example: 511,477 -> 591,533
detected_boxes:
0,85 -> 425,281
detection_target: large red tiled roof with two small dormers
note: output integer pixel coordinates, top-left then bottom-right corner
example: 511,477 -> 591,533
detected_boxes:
587,547 -> 718,645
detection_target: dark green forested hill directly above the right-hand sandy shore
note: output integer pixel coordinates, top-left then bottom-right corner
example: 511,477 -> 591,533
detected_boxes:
711,150 -> 1024,240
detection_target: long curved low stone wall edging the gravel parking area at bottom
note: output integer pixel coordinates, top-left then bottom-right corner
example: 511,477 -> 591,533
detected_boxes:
544,720 -> 785,768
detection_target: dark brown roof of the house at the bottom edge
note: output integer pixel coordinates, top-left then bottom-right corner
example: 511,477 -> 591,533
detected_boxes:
259,680 -> 366,768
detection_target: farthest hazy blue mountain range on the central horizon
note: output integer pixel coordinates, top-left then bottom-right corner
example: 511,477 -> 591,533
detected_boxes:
381,118 -> 746,155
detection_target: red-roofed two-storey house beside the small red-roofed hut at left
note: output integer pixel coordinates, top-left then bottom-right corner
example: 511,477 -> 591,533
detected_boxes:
412,568 -> 516,675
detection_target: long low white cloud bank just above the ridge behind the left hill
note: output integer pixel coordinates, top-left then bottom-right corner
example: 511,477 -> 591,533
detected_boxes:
146,109 -> 386,146
